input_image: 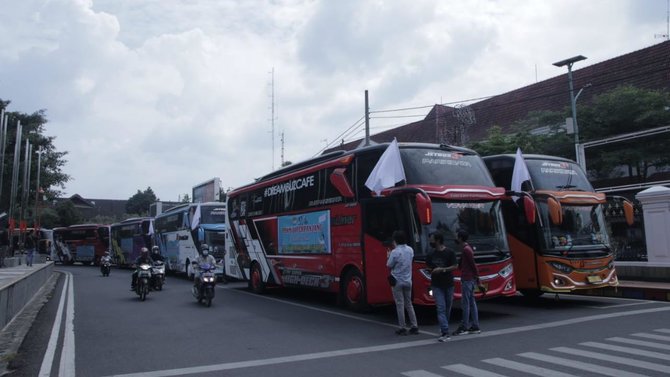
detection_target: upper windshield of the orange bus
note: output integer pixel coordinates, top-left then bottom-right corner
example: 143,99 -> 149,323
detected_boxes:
526,159 -> 593,192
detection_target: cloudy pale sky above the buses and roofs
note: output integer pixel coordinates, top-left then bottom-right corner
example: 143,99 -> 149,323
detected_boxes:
0,0 -> 669,201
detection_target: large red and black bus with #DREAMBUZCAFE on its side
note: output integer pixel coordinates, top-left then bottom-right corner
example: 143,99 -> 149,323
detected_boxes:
225,143 -> 516,310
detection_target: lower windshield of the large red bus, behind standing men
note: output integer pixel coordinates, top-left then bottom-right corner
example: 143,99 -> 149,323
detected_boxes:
417,201 -> 509,255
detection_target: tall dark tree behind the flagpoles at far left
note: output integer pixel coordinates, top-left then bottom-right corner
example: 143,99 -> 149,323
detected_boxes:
0,99 -> 70,219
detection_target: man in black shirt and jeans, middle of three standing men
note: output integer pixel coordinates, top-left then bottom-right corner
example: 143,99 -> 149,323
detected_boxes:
426,231 -> 458,342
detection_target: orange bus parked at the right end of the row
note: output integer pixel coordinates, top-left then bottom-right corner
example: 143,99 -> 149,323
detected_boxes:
484,154 -> 633,297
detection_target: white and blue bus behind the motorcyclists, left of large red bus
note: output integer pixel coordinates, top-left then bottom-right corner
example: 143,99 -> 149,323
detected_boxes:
154,202 -> 227,279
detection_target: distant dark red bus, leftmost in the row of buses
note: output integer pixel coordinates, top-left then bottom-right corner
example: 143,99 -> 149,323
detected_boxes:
54,224 -> 110,265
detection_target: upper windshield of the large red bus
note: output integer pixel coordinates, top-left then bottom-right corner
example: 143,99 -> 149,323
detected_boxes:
400,148 -> 494,186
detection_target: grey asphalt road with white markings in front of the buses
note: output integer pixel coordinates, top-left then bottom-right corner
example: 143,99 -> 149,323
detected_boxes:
5,266 -> 670,377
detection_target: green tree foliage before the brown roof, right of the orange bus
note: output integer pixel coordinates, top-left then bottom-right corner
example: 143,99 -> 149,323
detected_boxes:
470,86 -> 670,183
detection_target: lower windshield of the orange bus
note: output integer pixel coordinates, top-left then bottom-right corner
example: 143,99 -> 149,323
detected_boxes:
538,202 -> 609,251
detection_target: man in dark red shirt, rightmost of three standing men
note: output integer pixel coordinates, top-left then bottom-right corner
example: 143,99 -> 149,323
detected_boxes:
454,229 -> 481,335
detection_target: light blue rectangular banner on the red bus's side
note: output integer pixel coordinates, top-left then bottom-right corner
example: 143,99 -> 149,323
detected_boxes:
277,211 -> 330,254
